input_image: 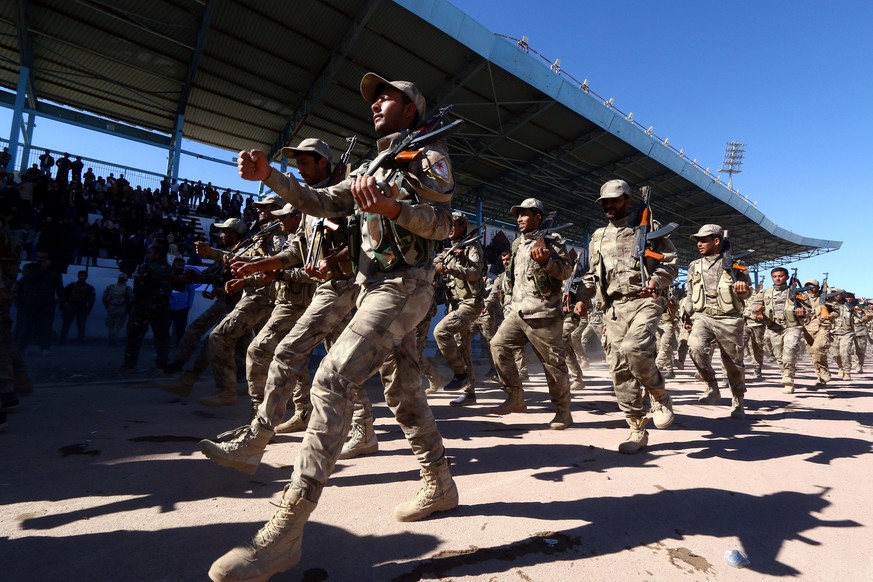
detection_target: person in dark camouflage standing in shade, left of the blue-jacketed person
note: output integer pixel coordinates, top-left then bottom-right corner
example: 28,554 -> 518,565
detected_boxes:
121,244 -> 171,373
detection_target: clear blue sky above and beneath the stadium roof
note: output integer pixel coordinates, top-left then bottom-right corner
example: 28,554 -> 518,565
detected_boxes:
0,0 -> 873,296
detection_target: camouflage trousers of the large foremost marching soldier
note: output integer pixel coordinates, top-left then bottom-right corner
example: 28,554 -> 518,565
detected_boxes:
291,277 -> 445,502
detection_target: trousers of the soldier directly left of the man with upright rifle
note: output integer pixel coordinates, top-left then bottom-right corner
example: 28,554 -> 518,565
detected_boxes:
491,312 -> 570,411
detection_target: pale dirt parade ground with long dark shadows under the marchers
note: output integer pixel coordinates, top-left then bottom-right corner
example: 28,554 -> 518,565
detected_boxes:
0,345 -> 873,582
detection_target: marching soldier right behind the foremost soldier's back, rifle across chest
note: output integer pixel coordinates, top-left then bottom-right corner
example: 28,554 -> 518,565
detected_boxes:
433,212 -> 485,406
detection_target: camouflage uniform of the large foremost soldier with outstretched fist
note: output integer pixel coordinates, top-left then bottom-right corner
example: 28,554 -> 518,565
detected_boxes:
265,126 -> 454,503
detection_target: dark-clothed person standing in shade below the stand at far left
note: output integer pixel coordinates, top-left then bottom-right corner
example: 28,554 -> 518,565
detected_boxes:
15,249 -> 64,354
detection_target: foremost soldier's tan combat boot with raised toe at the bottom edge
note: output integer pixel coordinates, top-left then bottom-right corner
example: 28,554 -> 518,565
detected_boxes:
209,483 -> 316,582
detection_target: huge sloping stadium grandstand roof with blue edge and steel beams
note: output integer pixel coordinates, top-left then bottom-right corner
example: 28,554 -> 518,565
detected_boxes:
0,0 -> 841,267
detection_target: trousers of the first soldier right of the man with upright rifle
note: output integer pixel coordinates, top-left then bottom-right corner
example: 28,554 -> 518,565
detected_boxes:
688,313 -> 746,397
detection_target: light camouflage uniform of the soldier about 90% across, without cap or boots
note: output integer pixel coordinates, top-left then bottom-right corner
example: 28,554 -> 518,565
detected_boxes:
753,285 -> 803,394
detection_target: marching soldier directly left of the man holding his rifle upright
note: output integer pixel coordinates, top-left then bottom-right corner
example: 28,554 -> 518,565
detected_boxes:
491,198 -> 573,430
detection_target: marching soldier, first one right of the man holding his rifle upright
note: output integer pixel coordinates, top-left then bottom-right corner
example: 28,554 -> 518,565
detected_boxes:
687,224 -> 752,418
